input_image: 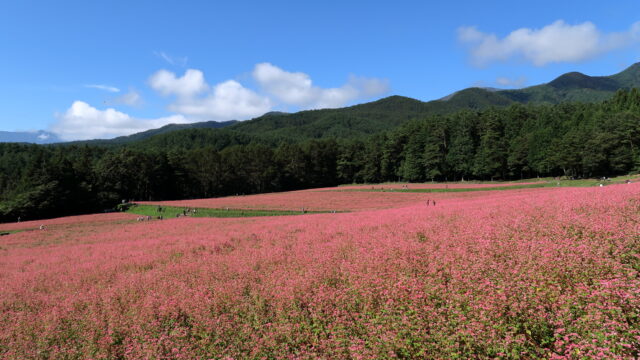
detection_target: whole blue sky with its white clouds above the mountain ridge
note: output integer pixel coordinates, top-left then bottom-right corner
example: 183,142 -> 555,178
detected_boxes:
0,0 -> 640,140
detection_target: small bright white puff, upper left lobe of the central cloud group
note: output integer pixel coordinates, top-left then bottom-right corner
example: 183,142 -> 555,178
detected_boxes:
149,69 -> 209,98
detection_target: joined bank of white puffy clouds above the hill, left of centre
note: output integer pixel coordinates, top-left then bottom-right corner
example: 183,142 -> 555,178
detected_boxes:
149,63 -> 389,121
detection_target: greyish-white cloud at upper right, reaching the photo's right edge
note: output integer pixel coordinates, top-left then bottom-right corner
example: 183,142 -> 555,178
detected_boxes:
458,20 -> 640,66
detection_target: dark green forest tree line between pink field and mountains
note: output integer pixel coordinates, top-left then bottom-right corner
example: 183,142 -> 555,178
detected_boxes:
0,89 -> 640,222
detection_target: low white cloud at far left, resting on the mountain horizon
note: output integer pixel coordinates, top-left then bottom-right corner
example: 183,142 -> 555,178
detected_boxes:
51,101 -> 188,140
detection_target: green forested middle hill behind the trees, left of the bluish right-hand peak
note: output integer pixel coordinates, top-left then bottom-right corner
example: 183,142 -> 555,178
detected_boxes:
132,88 -> 513,148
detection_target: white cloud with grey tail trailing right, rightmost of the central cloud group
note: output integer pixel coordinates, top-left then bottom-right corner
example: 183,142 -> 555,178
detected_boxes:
252,63 -> 389,109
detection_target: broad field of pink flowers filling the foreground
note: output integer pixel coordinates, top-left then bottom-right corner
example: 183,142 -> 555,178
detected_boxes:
0,184 -> 640,359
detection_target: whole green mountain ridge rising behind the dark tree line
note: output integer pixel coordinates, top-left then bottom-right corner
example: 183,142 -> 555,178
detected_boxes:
6,63 -> 640,146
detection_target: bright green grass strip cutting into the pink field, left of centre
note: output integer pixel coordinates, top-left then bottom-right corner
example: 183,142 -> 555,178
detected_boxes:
127,205 -> 329,219
